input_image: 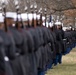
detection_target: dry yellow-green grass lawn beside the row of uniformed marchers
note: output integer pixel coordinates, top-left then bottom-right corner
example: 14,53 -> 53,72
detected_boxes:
46,48 -> 76,75
